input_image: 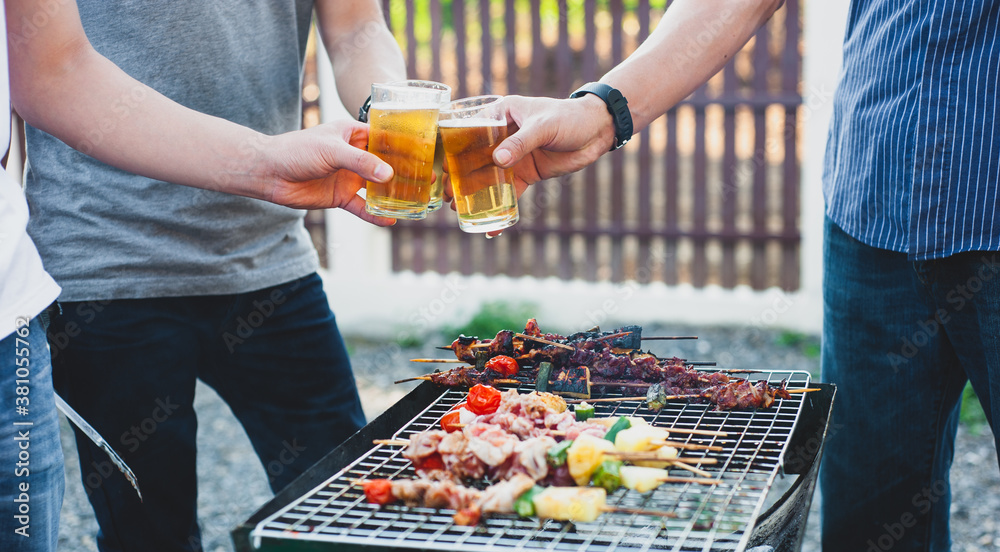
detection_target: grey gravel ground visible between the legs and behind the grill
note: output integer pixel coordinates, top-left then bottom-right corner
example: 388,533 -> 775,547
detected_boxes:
59,326 -> 1000,552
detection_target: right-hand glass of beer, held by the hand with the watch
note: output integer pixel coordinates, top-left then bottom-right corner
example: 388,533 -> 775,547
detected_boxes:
438,96 -> 518,232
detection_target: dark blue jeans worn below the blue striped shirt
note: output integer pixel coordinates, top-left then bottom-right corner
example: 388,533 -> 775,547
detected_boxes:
820,219 -> 1000,552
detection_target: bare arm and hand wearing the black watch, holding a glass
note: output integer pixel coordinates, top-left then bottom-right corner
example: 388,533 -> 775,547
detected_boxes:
493,0 -> 782,191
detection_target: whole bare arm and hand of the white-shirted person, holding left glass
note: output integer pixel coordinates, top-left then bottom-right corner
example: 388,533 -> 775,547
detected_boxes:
5,0 -> 392,225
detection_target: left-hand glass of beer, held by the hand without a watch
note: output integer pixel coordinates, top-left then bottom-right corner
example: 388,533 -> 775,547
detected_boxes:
365,80 -> 451,220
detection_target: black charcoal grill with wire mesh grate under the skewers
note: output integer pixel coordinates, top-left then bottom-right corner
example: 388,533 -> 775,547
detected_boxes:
233,371 -> 834,552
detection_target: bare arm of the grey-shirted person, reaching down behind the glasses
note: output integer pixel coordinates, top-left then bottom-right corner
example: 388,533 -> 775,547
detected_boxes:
316,0 -> 406,116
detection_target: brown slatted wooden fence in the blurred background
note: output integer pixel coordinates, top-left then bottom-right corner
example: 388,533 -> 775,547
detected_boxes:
324,0 -> 802,290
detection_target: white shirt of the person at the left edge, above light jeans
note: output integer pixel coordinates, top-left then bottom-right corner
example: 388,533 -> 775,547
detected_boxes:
0,0 -> 59,339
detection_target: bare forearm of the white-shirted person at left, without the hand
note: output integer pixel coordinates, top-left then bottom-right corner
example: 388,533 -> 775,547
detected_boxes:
11,43 -> 278,199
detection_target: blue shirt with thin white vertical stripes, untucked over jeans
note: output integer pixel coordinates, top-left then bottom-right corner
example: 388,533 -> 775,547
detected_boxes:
823,0 -> 1000,260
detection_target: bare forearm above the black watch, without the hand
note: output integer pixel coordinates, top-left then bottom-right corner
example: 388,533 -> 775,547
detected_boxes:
601,0 -> 782,132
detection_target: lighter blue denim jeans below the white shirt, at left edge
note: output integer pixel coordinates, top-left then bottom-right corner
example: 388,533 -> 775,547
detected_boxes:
0,315 -> 66,552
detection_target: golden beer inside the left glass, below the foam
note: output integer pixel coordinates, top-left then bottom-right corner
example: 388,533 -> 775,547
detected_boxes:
366,105 -> 439,219
